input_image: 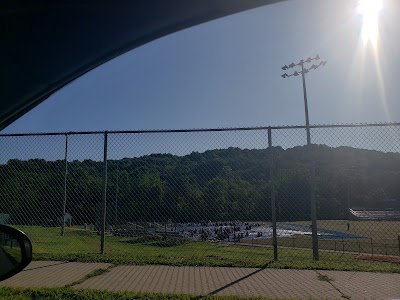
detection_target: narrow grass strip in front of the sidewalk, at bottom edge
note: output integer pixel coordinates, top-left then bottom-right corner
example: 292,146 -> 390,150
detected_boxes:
0,288 -> 267,300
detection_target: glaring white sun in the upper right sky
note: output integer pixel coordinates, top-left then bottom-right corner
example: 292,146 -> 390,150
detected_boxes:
358,0 -> 383,47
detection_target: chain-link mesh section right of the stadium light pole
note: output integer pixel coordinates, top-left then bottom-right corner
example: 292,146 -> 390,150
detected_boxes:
312,126 -> 400,261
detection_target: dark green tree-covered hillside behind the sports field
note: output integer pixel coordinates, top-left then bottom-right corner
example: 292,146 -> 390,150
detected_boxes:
0,145 -> 400,224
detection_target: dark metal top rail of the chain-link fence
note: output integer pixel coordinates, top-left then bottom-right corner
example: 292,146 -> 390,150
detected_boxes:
0,122 -> 400,137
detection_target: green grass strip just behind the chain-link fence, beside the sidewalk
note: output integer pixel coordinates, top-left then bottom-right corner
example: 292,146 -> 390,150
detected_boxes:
10,226 -> 400,273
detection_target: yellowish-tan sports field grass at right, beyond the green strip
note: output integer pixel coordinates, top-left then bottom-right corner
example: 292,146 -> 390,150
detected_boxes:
247,220 -> 400,256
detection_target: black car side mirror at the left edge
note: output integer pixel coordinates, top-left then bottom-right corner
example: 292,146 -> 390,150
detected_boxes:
0,225 -> 32,281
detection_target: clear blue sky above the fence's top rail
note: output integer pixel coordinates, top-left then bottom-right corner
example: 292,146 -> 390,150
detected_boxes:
3,0 -> 400,133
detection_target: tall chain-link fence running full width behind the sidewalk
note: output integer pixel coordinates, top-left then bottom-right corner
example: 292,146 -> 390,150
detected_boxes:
0,123 -> 400,266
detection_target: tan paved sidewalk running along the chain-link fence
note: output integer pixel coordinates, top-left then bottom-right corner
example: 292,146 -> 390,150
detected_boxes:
0,261 -> 400,299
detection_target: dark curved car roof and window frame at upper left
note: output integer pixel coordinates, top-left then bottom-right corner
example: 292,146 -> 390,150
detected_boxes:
0,0 -> 282,130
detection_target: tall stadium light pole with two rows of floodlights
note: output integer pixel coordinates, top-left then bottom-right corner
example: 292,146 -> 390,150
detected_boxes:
281,54 -> 327,260
